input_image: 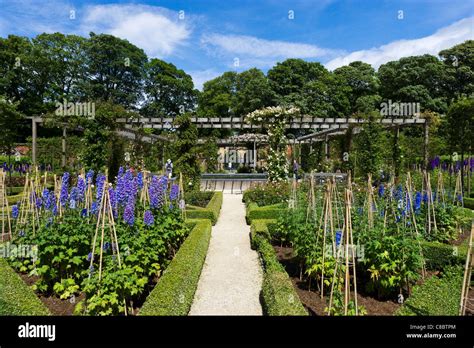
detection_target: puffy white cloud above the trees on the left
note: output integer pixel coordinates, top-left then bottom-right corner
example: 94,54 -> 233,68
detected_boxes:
80,5 -> 191,58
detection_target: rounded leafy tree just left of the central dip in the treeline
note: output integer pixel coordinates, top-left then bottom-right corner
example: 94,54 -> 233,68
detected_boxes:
142,59 -> 198,117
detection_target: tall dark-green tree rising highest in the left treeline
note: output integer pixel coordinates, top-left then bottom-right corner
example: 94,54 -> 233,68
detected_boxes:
86,33 -> 147,108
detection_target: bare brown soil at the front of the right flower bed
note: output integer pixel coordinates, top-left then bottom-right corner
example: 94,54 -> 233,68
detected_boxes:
273,246 -> 401,316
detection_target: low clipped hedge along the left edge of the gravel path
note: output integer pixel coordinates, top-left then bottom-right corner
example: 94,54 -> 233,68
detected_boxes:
139,220 -> 212,316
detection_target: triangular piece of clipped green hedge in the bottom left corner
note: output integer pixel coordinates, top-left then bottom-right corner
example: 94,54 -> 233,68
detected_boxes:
0,258 -> 51,315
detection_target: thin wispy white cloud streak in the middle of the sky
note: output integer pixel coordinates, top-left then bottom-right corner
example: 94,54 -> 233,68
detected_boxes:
201,34 -> 340,59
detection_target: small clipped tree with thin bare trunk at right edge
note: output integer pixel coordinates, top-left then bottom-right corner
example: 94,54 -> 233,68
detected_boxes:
447,98 -> 474,187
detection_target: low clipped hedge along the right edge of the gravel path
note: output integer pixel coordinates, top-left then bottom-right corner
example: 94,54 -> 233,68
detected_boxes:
250,220 -> 308,316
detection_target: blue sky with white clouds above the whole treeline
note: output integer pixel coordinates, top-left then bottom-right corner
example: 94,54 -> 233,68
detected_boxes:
0,0 -> 474,88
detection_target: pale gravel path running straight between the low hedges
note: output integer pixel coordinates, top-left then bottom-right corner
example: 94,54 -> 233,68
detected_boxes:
189,194 -> 262,315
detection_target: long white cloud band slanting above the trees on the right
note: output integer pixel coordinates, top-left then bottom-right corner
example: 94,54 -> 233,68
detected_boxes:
325,17 -> 474,70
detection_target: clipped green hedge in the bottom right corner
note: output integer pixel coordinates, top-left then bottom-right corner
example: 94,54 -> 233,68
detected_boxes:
395,266 -> 463,315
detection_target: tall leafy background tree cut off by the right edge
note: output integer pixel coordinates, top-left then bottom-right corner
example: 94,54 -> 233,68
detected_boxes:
439,40 -> 474,100
